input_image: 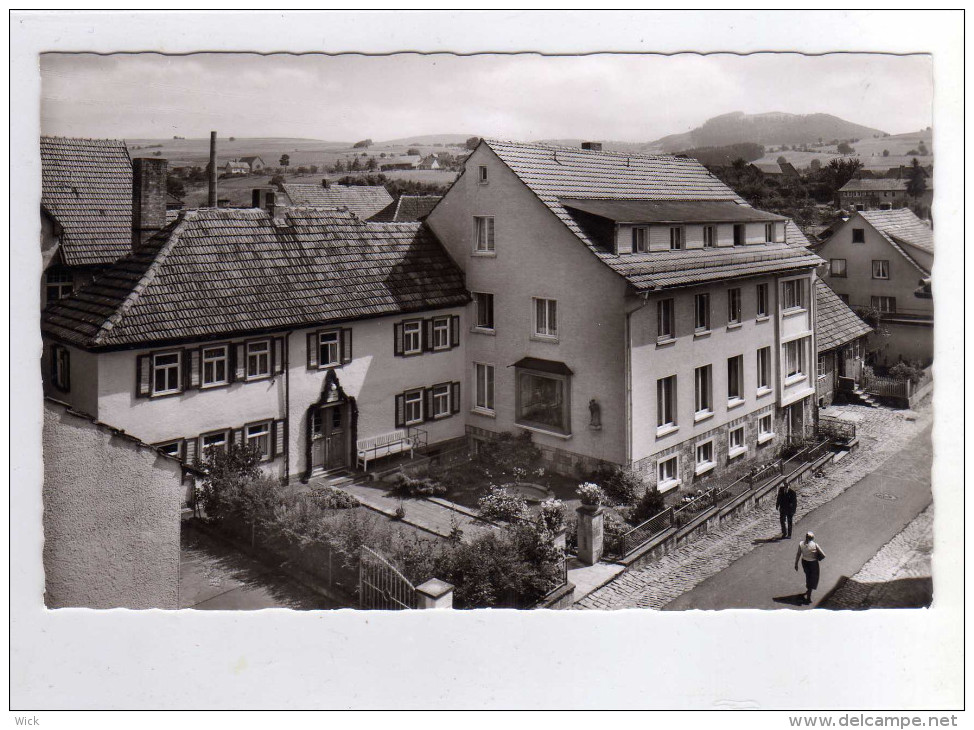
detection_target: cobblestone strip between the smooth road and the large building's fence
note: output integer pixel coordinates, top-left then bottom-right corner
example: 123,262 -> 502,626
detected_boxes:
574,398 -> 932,610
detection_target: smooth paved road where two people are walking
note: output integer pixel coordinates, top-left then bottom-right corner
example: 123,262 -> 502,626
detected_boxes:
664,426 -> 933,610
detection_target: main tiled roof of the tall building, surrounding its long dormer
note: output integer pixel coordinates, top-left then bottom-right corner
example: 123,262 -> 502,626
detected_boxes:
485,140 -> 822,289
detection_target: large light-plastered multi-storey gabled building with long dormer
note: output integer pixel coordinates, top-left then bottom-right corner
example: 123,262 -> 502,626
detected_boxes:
426,141 -> 821,491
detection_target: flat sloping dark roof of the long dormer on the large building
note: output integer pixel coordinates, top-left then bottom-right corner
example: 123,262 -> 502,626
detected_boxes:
561,198 -> 785,223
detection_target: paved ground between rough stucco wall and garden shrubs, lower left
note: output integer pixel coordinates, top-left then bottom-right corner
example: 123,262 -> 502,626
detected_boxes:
179,522 -> 340,611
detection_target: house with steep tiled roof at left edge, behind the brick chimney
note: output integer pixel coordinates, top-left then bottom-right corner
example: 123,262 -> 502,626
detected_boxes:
40,137 -> 141,306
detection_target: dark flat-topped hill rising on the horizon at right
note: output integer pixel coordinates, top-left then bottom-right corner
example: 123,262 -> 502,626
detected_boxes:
645,112 -> 885,152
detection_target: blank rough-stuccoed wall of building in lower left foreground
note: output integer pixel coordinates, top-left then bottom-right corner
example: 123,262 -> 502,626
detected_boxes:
43,398 -> 191,609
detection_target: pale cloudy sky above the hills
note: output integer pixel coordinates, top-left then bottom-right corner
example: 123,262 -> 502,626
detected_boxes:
40,54 -> 933,142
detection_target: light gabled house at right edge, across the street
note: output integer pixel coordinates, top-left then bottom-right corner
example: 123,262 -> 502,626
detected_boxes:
815,208 -> 934,366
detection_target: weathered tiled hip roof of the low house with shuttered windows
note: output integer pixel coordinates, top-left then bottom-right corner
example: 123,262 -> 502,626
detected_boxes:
42,208 -> 469,349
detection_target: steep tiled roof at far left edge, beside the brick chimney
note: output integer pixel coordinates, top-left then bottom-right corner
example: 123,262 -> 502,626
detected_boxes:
41,137 -> 132,266
